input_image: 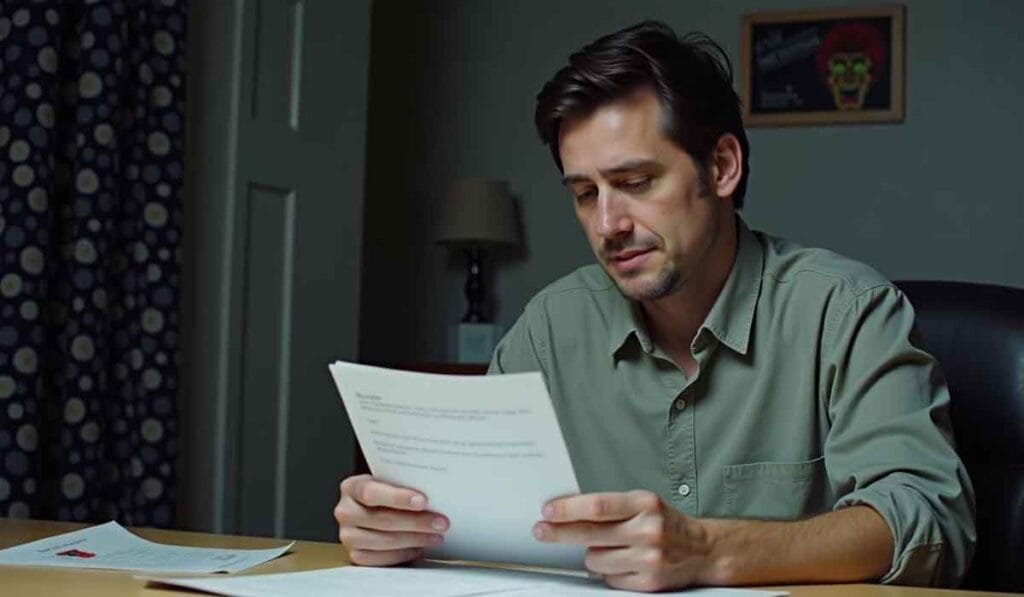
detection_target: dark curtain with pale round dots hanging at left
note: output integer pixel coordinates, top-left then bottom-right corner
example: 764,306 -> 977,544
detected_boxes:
0,0 -> 186,526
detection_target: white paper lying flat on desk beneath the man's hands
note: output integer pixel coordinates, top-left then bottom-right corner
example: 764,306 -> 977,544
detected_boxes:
145,566 -> 786,597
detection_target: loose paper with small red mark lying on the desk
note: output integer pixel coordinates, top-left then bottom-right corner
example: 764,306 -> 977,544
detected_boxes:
0,521 -> 295,573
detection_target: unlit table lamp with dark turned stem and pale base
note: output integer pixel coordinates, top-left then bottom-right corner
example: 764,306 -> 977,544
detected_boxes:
434,178 -> 519,363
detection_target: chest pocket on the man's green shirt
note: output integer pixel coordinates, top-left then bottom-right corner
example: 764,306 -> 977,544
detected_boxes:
723,457 -> 830,520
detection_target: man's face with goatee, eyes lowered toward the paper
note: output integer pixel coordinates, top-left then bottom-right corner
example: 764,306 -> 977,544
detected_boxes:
559,89 -> 731,301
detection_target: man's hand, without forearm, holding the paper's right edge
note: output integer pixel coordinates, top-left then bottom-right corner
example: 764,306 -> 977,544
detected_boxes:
534,491 -> 717,591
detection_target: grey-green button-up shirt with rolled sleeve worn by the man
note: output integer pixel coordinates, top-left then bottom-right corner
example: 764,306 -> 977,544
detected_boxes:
490,218 -> 975,586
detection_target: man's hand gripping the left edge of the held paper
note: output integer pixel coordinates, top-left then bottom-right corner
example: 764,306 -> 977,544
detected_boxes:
334,475 -> 449,566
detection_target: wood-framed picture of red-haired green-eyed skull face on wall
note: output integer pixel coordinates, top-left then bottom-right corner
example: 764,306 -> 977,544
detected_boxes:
740,6 -> 904,126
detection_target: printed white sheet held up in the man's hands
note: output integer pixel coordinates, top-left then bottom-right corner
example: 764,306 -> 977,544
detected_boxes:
331,363 -> 584,568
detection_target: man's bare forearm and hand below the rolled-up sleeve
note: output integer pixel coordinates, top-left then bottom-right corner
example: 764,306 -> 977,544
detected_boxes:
534,491 -> 894,591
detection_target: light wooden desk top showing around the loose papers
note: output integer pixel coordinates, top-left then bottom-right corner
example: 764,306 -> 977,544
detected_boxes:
0,518 -> 1011,597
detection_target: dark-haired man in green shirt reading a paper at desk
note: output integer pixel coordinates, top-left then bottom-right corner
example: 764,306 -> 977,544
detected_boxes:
335,23 -> 975,591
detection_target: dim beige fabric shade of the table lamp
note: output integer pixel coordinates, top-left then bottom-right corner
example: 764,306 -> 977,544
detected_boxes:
434,178 -> 519,245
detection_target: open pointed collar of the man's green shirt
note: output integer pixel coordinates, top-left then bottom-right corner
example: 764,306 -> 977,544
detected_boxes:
608,216 -> 764,356
